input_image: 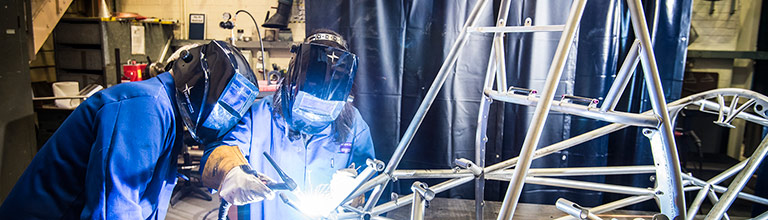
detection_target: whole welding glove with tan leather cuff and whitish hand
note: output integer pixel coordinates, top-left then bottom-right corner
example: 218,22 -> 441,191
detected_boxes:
203,146 -> 275,205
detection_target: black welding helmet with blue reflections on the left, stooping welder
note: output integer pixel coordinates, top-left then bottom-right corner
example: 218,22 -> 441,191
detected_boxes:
172,41 -> 259,143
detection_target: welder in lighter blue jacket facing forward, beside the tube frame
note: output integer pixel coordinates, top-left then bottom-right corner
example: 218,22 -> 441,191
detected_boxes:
203,29 -> 374,220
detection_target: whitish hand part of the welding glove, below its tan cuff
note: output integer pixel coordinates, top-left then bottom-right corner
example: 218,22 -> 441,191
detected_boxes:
219,165 -> 275,205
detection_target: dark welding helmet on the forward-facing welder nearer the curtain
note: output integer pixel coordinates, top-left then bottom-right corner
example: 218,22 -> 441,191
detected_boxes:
280,33 -> 357,134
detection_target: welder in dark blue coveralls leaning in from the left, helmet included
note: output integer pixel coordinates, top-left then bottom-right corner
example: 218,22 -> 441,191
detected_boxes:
0,41 -> 271,219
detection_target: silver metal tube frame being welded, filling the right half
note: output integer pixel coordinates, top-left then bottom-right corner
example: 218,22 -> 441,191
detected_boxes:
339,0 -> 768,219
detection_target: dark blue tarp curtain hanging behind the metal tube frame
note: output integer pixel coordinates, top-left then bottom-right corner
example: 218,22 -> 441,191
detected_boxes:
305,0 -> 692,206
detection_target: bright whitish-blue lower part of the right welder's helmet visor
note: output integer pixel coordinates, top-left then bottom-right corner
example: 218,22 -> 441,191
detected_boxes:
291,91 -> 345,134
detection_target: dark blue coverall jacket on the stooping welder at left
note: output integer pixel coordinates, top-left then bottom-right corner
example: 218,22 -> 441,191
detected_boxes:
0,73 -> 182,219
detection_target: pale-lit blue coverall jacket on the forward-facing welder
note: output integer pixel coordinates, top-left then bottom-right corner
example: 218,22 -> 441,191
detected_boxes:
203,96 -> 374,220
